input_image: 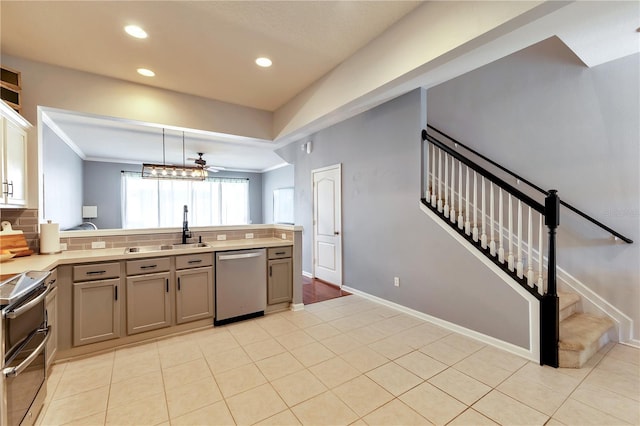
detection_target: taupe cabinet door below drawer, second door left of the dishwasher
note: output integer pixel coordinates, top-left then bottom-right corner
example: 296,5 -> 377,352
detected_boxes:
127,272 -> 171,334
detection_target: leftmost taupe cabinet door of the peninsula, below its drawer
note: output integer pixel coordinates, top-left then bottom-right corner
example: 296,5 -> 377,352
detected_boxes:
73,279 -> 121,346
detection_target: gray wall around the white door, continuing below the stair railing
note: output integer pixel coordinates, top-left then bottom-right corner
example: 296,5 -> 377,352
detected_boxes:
278,89 -> 529,348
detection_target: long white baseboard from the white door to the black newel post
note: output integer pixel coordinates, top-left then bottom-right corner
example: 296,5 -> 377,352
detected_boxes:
342,285 -> 540,362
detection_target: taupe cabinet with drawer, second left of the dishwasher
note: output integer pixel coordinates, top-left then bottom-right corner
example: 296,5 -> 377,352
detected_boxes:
126,257 -> 172,335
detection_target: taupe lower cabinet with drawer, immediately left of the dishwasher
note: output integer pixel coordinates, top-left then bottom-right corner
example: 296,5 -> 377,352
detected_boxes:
176,253 -> 215,324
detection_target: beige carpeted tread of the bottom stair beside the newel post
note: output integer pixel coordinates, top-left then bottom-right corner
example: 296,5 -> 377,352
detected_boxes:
559,313 -> 613,351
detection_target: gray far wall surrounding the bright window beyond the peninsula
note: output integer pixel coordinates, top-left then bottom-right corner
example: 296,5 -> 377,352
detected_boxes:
83,161 -> 262,229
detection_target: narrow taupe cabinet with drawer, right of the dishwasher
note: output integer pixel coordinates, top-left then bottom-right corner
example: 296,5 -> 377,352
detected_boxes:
267,247 -> 293,305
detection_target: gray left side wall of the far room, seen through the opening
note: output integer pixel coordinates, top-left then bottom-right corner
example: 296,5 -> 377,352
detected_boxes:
42,125 -> 83,229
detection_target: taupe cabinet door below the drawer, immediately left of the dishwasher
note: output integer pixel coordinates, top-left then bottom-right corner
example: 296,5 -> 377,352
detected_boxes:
176,267 -> 215,324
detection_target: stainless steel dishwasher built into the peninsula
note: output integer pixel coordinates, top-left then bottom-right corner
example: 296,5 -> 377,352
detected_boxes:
213,249 -> 267,325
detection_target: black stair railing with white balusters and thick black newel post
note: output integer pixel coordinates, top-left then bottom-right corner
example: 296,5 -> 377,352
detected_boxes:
422,126 -> 560,367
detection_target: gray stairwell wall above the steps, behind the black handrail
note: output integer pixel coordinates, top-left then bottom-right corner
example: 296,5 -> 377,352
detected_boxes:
427,38 -> 640,339
